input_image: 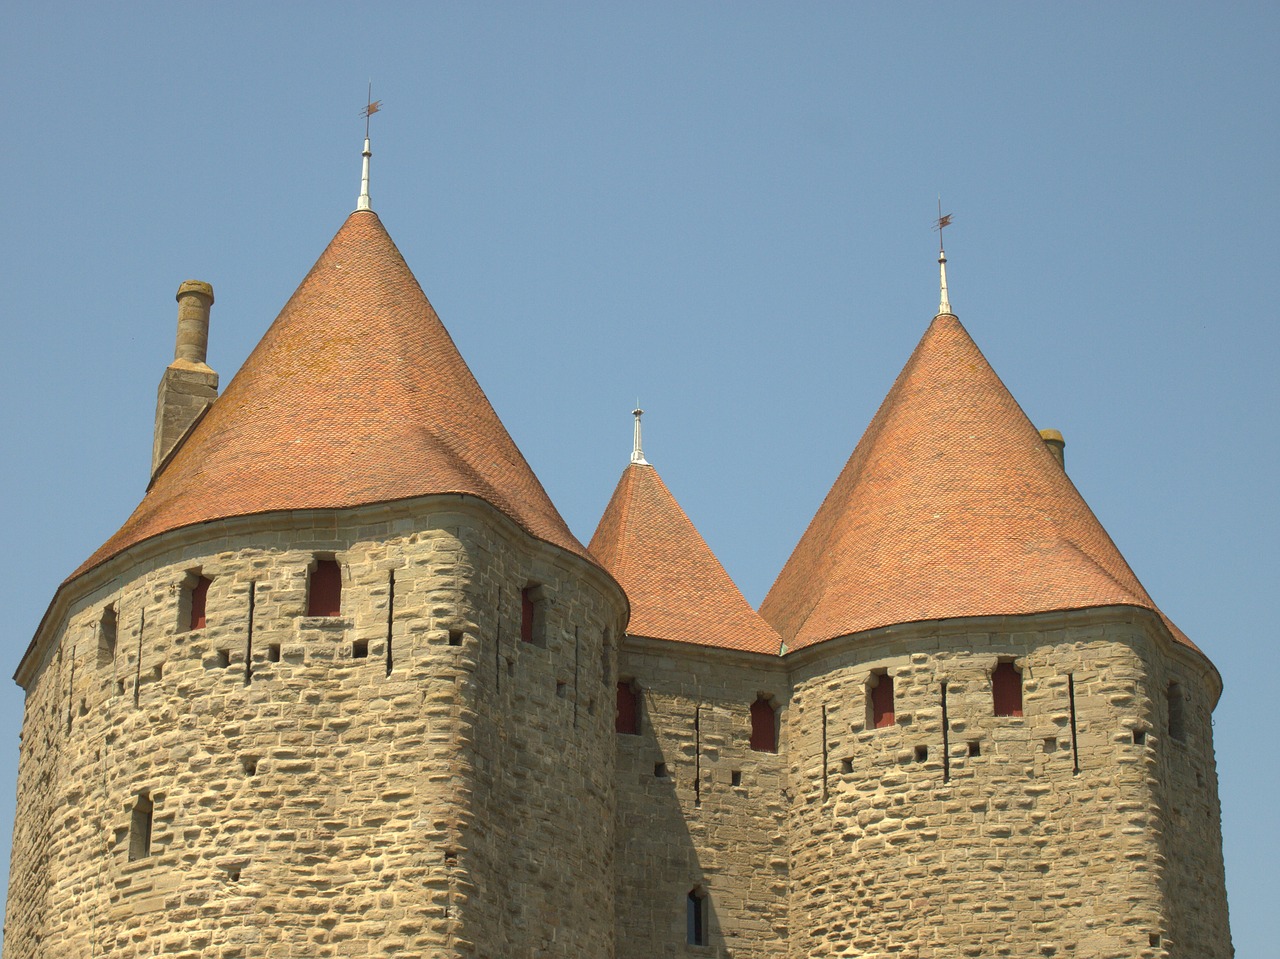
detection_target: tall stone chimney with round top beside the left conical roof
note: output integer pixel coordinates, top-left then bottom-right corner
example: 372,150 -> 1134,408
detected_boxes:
151,279 -> 218,480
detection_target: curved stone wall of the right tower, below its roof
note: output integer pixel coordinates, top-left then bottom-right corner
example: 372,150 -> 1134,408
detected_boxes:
787,608 -> 1231,959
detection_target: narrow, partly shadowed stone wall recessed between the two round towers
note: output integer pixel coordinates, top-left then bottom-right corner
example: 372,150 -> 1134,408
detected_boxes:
614,638 -> 788,959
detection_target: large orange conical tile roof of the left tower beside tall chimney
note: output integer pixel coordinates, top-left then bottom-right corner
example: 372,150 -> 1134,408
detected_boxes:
73,210 -> 586,577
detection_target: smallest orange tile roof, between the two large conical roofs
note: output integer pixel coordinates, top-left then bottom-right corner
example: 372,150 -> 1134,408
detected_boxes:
588,463 -> 778,654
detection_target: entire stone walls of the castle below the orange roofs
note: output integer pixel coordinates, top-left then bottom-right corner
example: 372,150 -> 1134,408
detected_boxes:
4,519 -> 1231,959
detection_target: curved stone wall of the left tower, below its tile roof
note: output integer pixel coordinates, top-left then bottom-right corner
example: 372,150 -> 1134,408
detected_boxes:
4,498 -> 623,959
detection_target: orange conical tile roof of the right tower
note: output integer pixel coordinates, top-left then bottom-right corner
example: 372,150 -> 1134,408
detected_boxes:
760,314 -> 1194,649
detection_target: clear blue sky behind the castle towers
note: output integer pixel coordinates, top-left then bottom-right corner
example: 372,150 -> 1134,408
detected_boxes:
0,1 -> 1280,959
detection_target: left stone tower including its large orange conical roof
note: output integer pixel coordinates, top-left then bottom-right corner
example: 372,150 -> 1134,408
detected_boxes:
4,211 -> 627,959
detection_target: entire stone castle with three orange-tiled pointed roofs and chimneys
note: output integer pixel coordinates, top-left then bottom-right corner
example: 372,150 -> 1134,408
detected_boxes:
4,141 -> 1233,959
